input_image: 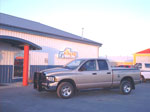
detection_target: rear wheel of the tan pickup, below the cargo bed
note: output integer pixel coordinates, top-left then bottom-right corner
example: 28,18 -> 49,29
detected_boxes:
120,80 -> 132,95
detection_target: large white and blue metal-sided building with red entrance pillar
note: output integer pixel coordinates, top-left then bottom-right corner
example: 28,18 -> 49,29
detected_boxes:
0,13 -> 102,83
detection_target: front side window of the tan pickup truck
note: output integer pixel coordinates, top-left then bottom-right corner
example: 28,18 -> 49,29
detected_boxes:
79,60 -> 96,71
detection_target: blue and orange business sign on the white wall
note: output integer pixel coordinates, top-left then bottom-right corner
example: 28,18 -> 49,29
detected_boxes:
58,48 -> 78,58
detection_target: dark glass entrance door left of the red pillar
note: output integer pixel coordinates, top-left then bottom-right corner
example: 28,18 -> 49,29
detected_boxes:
14,57 -> 23,78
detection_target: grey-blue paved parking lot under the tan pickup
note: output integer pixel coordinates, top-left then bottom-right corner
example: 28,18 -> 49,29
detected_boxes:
0,82 -> 150,112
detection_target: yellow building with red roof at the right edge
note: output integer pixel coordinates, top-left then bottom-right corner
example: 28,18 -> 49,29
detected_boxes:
133,48 -> 150,64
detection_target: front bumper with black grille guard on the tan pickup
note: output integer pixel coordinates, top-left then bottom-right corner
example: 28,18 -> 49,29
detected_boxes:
33,72 -> 58,91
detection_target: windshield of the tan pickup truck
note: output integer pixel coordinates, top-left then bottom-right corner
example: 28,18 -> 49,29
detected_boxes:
65,59 -> 84,69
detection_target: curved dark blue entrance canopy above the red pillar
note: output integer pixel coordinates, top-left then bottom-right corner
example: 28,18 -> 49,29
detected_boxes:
0,35 -> 42,50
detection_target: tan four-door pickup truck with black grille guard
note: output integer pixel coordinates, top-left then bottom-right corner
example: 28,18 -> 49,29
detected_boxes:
33,58 -> 140,99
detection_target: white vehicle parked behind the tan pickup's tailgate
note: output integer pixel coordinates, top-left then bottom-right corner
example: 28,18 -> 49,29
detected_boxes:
135,63 -> 150,82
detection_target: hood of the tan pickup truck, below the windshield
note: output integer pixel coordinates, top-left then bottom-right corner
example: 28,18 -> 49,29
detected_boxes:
41,67 -> 72,76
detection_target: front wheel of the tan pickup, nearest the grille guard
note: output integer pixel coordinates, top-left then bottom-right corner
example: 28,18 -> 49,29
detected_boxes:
57,82 -> 74,99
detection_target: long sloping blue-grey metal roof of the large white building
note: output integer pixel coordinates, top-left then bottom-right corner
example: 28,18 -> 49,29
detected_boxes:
0,13 -> 102,46
